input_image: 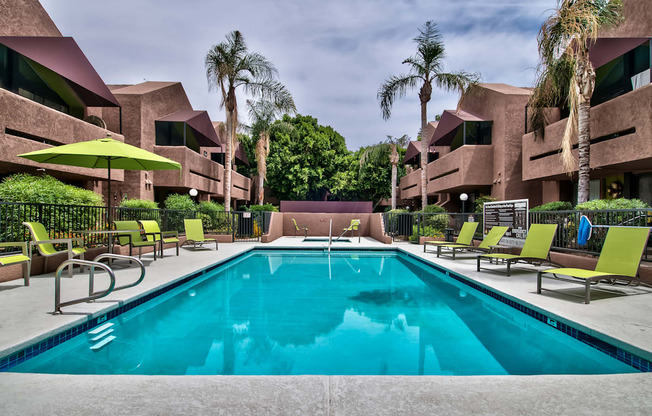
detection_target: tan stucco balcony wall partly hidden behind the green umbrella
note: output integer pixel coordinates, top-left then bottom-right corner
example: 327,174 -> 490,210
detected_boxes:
0,89 -> 124,182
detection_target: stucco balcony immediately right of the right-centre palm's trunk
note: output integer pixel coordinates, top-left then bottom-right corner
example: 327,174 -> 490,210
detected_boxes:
428,145 -> 493,195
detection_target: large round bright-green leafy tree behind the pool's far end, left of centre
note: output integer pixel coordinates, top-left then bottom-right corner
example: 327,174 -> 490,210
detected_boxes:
267,114 -> 350,200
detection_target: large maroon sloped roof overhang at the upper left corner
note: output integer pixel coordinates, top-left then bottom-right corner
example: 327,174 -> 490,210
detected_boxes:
0,36 -> 120,107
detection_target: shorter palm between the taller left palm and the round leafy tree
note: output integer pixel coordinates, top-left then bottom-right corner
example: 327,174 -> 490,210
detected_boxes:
247,97 -> 297,205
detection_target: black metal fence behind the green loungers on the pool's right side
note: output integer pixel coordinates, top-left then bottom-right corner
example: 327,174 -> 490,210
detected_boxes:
383,208 -> 652,260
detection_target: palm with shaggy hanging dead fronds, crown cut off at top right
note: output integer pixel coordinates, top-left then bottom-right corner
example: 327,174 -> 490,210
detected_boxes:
529,0 -> 623,203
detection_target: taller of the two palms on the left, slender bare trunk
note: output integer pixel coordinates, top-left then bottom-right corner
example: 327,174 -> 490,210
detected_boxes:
205,30 -> 291,211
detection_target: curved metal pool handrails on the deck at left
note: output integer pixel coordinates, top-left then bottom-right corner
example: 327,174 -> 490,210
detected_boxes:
54,253 -> 145,313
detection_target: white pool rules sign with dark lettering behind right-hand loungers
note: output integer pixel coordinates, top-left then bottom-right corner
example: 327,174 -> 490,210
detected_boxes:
482,199 -> 529,247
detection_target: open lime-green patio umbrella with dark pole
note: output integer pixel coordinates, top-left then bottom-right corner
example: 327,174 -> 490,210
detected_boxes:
18,137 -> 181,223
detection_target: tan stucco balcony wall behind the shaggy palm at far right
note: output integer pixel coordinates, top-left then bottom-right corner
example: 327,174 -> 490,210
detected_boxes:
522,84 -> 652,180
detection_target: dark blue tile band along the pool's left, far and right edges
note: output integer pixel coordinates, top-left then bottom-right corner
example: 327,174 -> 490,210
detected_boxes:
0,246 -> 652,373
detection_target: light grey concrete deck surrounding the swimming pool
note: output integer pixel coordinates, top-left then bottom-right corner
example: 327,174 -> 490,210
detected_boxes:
0,237 -> 652,415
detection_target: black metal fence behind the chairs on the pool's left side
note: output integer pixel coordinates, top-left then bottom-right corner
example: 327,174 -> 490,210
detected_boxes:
0,201 -> 271,246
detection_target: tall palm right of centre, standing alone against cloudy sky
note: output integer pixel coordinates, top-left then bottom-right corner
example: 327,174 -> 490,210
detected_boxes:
378,21 -> 480,209
